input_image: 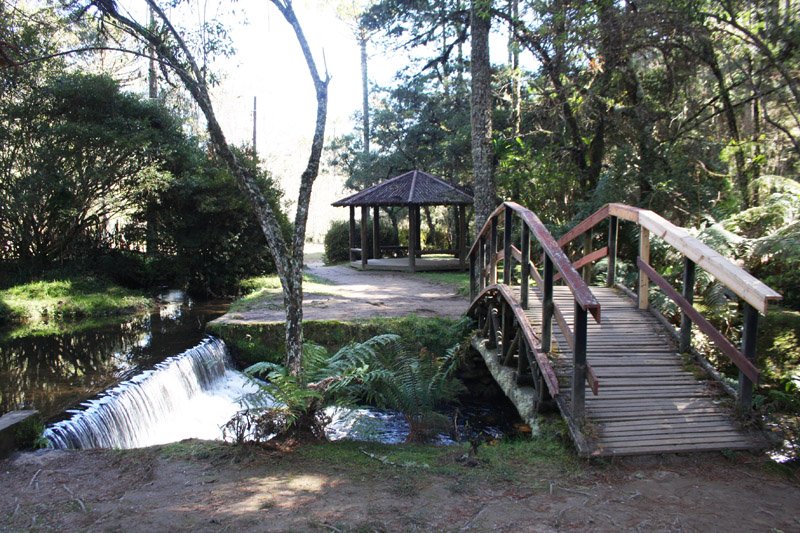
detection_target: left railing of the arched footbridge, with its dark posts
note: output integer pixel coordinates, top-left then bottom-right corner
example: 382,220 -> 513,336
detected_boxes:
468,202 -> 600,420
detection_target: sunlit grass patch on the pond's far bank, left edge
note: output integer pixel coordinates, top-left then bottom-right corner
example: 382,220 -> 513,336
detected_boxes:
0,276 -> 151,324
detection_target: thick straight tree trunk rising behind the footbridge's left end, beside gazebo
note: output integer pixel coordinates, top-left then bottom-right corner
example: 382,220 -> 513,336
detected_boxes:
470,0 -> 497,232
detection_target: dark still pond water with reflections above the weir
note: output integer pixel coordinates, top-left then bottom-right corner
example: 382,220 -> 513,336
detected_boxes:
0,291 -> 225,418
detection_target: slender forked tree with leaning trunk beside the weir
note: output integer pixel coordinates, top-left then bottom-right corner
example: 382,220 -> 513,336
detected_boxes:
91,0 -> 330,375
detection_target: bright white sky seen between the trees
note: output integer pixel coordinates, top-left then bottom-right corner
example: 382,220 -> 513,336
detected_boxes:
205,0 -> 396,237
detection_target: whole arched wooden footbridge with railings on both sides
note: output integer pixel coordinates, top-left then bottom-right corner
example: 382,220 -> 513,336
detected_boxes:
469,202 -> 780,456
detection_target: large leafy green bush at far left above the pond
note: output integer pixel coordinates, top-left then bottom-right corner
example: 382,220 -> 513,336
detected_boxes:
0,73 -> 183,267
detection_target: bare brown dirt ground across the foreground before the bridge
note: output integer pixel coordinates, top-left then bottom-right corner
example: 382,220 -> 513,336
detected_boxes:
0,445 -> 800,532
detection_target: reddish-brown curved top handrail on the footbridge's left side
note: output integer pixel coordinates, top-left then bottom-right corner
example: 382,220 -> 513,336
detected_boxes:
467,202 -> 600,316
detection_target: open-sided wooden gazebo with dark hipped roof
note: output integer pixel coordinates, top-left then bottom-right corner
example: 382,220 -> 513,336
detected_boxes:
332,170 -> 473,272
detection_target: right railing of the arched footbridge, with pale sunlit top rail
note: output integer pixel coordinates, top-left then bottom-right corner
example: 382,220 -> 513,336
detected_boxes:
557,204 -> 781,411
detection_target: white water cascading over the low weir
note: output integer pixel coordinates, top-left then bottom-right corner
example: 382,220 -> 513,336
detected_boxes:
45,337 -> 254,449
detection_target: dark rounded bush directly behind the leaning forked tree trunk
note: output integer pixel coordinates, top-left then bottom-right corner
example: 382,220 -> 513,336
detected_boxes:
124,145 -> 291,297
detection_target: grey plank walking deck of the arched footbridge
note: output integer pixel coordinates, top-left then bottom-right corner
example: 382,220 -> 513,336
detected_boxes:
515,287 -> 764,456
